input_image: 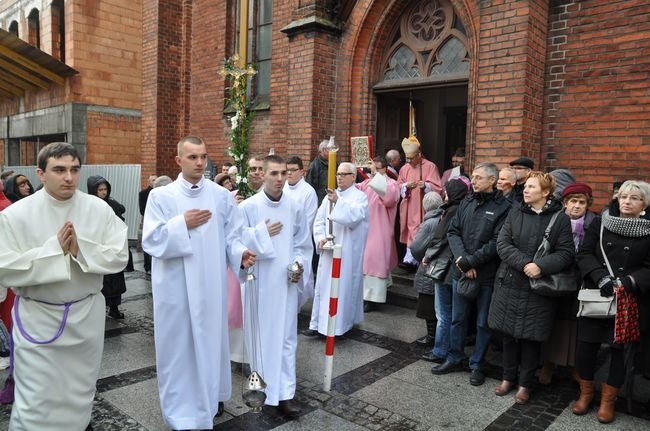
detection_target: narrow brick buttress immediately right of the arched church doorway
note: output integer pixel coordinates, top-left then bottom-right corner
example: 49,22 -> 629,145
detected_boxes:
470,0 -> 548,166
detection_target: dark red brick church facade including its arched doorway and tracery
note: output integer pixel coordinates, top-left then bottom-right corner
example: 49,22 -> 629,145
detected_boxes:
142,0 -> 650,208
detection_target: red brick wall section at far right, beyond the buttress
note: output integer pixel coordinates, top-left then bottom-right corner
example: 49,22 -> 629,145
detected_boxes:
542,0 -> 650,207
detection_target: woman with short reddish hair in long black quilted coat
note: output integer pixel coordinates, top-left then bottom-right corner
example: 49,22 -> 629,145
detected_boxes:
488,172 -> 575,404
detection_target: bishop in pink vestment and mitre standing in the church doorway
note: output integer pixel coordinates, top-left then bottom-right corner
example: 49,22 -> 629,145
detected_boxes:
397,136 -> 442,247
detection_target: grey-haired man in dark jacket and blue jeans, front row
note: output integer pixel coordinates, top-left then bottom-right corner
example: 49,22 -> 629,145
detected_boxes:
431,163 -> 511,386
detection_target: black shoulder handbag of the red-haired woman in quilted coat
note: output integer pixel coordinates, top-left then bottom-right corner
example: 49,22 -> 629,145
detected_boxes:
529,211 -> 579,296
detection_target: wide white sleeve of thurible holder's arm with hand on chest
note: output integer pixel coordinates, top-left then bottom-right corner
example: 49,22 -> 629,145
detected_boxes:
142,188 -> 193,259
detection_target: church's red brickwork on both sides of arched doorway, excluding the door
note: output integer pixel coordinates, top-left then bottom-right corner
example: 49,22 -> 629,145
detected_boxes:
143,0 -> 650,208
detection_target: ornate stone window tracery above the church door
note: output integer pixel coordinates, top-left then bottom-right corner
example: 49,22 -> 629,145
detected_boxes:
381,0 -> 469,84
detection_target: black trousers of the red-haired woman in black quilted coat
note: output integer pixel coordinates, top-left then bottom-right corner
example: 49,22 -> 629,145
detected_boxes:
502,334 -> 542,389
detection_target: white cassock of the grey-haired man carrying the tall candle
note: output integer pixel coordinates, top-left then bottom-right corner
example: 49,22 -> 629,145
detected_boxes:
309,186 -> 368,336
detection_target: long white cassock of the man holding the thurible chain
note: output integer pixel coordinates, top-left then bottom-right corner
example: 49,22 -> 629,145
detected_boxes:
142,175 -> 245,429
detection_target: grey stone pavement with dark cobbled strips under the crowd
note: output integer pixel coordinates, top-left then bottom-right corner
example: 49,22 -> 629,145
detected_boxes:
0,253 -> 650,431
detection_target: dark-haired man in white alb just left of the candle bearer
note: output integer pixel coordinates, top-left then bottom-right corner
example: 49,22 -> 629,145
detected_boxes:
282,156 -> 318,307
